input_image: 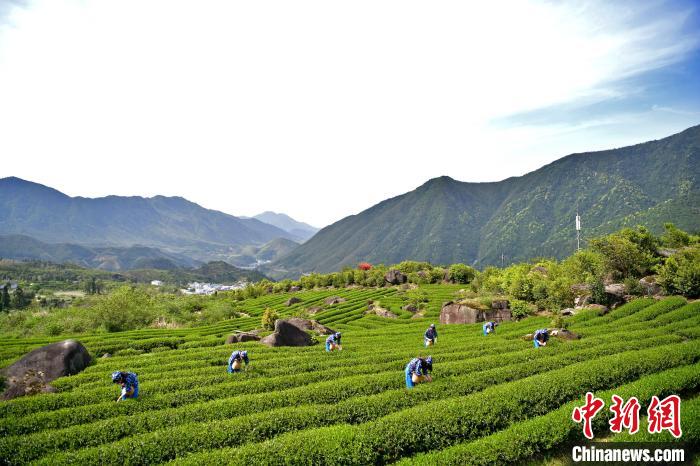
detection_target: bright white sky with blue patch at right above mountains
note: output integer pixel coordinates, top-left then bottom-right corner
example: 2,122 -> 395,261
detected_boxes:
0,0 -> 700,227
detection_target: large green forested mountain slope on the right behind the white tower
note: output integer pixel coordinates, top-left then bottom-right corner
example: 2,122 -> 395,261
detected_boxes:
276,126 -> 700,276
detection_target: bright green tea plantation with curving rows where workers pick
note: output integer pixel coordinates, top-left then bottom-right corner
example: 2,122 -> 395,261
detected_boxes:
0,285 -> 700,465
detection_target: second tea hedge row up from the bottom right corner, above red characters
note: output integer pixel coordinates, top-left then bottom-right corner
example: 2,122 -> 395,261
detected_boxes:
170,344 -> 700,464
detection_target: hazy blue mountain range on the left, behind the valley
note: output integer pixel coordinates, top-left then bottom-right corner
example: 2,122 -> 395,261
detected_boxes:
0,177 -> 308,270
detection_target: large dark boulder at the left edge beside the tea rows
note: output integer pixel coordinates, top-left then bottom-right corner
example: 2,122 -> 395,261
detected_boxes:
0,340 -> 92,400
